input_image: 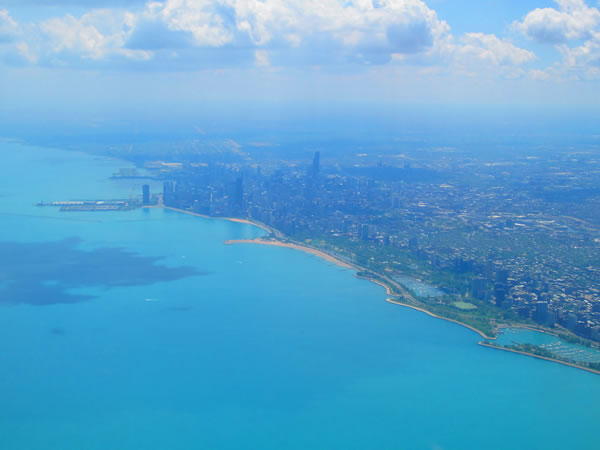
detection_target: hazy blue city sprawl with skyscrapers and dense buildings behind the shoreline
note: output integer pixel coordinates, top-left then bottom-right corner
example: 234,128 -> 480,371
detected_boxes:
149,152 -> 600,340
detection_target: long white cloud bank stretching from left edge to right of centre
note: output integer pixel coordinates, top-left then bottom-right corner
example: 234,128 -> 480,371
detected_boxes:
0,0 -> 536,73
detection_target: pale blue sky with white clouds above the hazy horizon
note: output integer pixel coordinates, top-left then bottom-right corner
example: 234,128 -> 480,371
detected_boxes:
0,0 -> 600,123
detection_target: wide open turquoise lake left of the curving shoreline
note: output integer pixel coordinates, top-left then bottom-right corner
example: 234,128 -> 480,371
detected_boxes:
0,143 -> 600,450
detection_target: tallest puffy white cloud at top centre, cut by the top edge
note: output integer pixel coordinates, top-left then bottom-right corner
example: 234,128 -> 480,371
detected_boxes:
145,0 -> 449,62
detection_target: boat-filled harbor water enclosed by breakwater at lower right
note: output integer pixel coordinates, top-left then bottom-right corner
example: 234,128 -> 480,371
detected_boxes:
494,328 -> 600,362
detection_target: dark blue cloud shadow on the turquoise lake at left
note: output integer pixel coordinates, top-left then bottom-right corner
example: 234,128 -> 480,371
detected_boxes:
0,238 -> 208,305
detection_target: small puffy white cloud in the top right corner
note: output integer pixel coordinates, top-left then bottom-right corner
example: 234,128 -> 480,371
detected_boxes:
513,0 -> 600,44
